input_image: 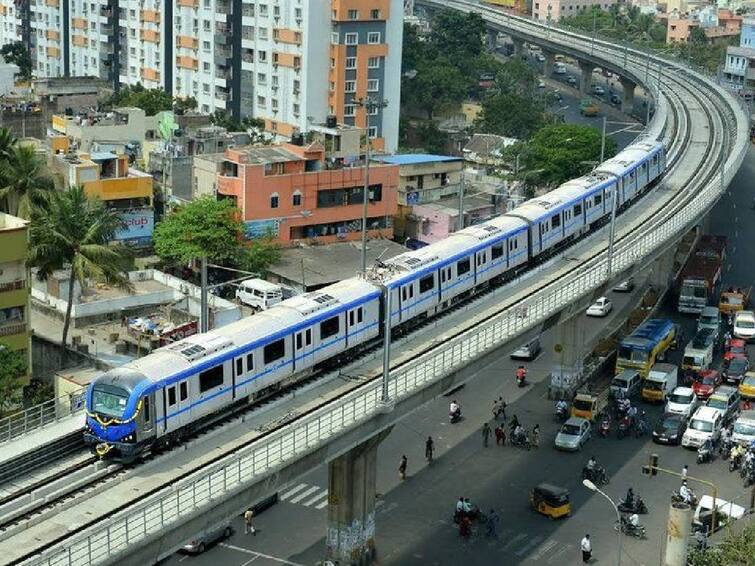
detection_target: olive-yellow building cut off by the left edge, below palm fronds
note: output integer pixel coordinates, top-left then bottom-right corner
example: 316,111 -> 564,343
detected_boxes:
0,212 -> 31,372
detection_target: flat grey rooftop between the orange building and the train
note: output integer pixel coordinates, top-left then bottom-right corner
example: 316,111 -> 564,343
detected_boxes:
268,240 -> 407,289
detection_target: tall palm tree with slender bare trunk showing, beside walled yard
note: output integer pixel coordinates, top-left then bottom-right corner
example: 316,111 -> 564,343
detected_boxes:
29,186 -> 133,351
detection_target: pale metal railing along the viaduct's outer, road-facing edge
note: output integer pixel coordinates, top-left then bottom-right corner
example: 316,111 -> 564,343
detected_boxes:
25,13 -> 747,566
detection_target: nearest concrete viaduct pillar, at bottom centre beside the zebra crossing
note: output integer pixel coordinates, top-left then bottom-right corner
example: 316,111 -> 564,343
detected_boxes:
326,431 -> 389,566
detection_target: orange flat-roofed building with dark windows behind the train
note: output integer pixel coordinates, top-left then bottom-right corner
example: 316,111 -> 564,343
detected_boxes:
217,143 -> 399,245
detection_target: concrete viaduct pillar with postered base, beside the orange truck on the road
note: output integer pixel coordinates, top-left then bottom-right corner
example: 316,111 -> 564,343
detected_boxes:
548,316 -> 587,399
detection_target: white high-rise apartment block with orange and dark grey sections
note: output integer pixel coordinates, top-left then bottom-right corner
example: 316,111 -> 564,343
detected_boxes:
8,0 -> 403,151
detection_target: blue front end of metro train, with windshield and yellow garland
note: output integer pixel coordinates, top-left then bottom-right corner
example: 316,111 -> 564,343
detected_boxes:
84,367 -> 152,462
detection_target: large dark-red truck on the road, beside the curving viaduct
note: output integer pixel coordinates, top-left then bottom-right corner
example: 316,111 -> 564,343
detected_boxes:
678,235 -> 726,314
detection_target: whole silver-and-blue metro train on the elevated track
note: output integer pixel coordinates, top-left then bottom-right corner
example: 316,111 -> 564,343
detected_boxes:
84,142 -> 666,461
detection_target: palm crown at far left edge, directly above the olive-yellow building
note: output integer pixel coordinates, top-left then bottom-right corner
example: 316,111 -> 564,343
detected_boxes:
0,145 -> 54,220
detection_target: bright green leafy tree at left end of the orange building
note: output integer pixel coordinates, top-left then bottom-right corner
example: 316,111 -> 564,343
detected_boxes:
152,197 -> 244,265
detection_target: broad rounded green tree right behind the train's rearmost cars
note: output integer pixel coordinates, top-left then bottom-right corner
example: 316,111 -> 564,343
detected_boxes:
508,124 -> 616,186
